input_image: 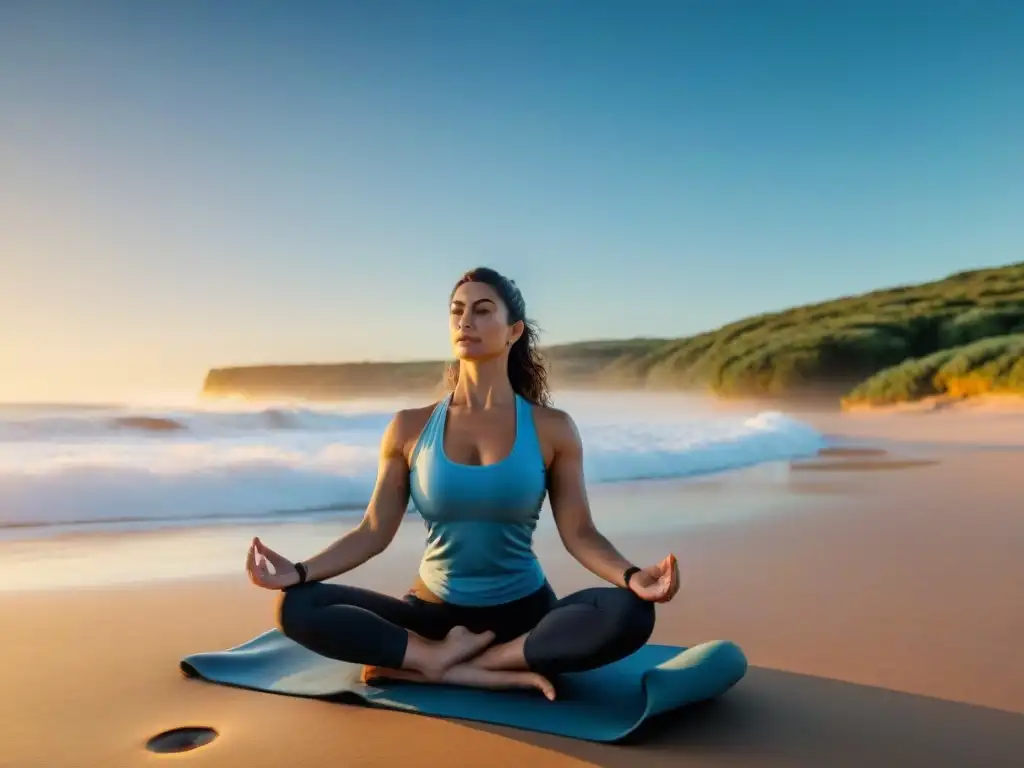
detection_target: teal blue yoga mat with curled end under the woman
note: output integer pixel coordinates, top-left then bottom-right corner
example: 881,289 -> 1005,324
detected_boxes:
180,630 -> 746,741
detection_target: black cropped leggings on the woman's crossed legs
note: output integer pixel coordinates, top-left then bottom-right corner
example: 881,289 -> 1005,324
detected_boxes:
278,583 -> 654,676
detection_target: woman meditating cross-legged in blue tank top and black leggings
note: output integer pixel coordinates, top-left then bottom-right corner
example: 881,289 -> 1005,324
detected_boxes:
247,268 -> 679,699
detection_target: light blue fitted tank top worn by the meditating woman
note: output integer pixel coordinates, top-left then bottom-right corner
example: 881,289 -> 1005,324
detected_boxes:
410,394 -> 547,606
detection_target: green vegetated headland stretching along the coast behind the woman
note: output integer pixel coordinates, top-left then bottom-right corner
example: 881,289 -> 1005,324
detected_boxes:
204,262 -> 1024,403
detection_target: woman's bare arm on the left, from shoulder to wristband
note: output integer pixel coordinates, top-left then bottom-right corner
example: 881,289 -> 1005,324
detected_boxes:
290,411 -> 415,582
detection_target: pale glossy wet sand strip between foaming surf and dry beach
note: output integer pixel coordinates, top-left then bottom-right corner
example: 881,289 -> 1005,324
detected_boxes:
0,462 -> 813,595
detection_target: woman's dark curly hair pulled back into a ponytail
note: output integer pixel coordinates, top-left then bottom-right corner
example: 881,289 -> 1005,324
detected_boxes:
445,266 -> 551,406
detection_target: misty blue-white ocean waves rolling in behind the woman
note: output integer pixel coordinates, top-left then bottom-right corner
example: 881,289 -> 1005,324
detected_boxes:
0,392 -> 825,538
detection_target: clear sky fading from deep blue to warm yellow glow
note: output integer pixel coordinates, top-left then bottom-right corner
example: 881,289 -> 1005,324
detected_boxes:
0,0 -> 1024,400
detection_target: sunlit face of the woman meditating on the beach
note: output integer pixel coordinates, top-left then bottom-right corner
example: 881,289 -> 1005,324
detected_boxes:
449,283 -> 522,360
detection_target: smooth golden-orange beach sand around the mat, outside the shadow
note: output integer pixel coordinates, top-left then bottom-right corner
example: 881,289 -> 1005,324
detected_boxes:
0,413 -> 1024,768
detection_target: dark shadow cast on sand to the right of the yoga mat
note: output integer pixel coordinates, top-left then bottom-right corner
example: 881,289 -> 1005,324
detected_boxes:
452,668 -> 1024,768
